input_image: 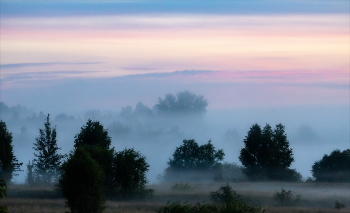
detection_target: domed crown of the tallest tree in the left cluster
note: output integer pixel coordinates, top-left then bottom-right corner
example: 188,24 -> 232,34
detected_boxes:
74,119 -> 111,148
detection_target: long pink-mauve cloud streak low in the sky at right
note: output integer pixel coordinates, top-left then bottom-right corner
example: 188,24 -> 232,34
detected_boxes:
113,70 -> 349,89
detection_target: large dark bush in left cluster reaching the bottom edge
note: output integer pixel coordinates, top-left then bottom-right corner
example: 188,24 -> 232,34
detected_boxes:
58,147 -> 105,213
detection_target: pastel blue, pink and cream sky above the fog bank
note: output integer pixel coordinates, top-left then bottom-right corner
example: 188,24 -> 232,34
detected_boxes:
0,1 -> 350,110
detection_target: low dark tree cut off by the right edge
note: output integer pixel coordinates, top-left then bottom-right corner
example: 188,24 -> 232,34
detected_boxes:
311,149 -> 350,182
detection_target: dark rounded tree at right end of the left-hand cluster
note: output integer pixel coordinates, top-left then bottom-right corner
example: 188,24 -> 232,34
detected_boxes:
113,149 -> 149,199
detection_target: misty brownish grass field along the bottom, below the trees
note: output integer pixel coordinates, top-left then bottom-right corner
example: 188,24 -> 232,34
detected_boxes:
0,182 -> 350,213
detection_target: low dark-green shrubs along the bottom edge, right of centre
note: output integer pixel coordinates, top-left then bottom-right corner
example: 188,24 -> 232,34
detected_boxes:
156,184 -> 265,213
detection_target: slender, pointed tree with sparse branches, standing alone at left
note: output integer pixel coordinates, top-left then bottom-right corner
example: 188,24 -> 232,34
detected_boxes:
33,114 -> 65,185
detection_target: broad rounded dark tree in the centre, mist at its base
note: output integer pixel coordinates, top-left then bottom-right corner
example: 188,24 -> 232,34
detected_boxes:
164,139 -> 225,180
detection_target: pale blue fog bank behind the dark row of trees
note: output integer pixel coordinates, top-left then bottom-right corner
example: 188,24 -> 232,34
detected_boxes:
0,93 -> 350,183
